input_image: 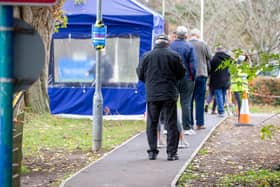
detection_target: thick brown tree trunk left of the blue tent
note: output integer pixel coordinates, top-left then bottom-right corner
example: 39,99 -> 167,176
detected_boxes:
15,6 -> 54,113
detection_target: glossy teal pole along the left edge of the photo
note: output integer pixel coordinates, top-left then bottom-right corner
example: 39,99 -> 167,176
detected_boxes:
0,5 -> 13,187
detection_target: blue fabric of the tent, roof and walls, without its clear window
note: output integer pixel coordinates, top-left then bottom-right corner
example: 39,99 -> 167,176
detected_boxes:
49,0 -> 164,115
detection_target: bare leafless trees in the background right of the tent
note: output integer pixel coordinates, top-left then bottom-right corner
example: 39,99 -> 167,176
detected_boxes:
138,0 -> 280,56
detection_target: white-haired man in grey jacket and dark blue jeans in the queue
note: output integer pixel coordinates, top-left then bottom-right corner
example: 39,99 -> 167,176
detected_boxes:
189,29 -> 212,130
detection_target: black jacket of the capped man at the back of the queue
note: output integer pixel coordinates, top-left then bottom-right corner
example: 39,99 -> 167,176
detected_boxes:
136,45 -> 185,102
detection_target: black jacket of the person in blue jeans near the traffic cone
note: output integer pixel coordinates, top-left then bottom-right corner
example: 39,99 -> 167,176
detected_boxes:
210,51 -> 231,89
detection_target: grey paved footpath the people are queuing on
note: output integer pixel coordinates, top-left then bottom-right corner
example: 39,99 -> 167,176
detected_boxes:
61,115 -> 224,187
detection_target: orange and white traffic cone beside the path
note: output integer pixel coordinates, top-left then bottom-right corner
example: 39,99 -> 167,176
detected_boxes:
238,91 -> 252,125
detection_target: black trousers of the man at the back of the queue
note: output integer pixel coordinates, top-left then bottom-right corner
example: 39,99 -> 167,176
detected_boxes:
146,100 -> 179,154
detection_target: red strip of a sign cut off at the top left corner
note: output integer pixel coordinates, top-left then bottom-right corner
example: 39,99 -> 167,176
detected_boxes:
0,0 -> 57,6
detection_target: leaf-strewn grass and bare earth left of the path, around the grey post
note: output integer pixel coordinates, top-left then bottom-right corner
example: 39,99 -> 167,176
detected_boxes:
21,112 -> 145,187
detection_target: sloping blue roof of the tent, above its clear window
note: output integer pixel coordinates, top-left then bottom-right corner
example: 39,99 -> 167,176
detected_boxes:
62,0 -> 163,27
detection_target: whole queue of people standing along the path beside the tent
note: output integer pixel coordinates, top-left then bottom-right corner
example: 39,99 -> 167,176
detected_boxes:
136,26 -> 245,161
